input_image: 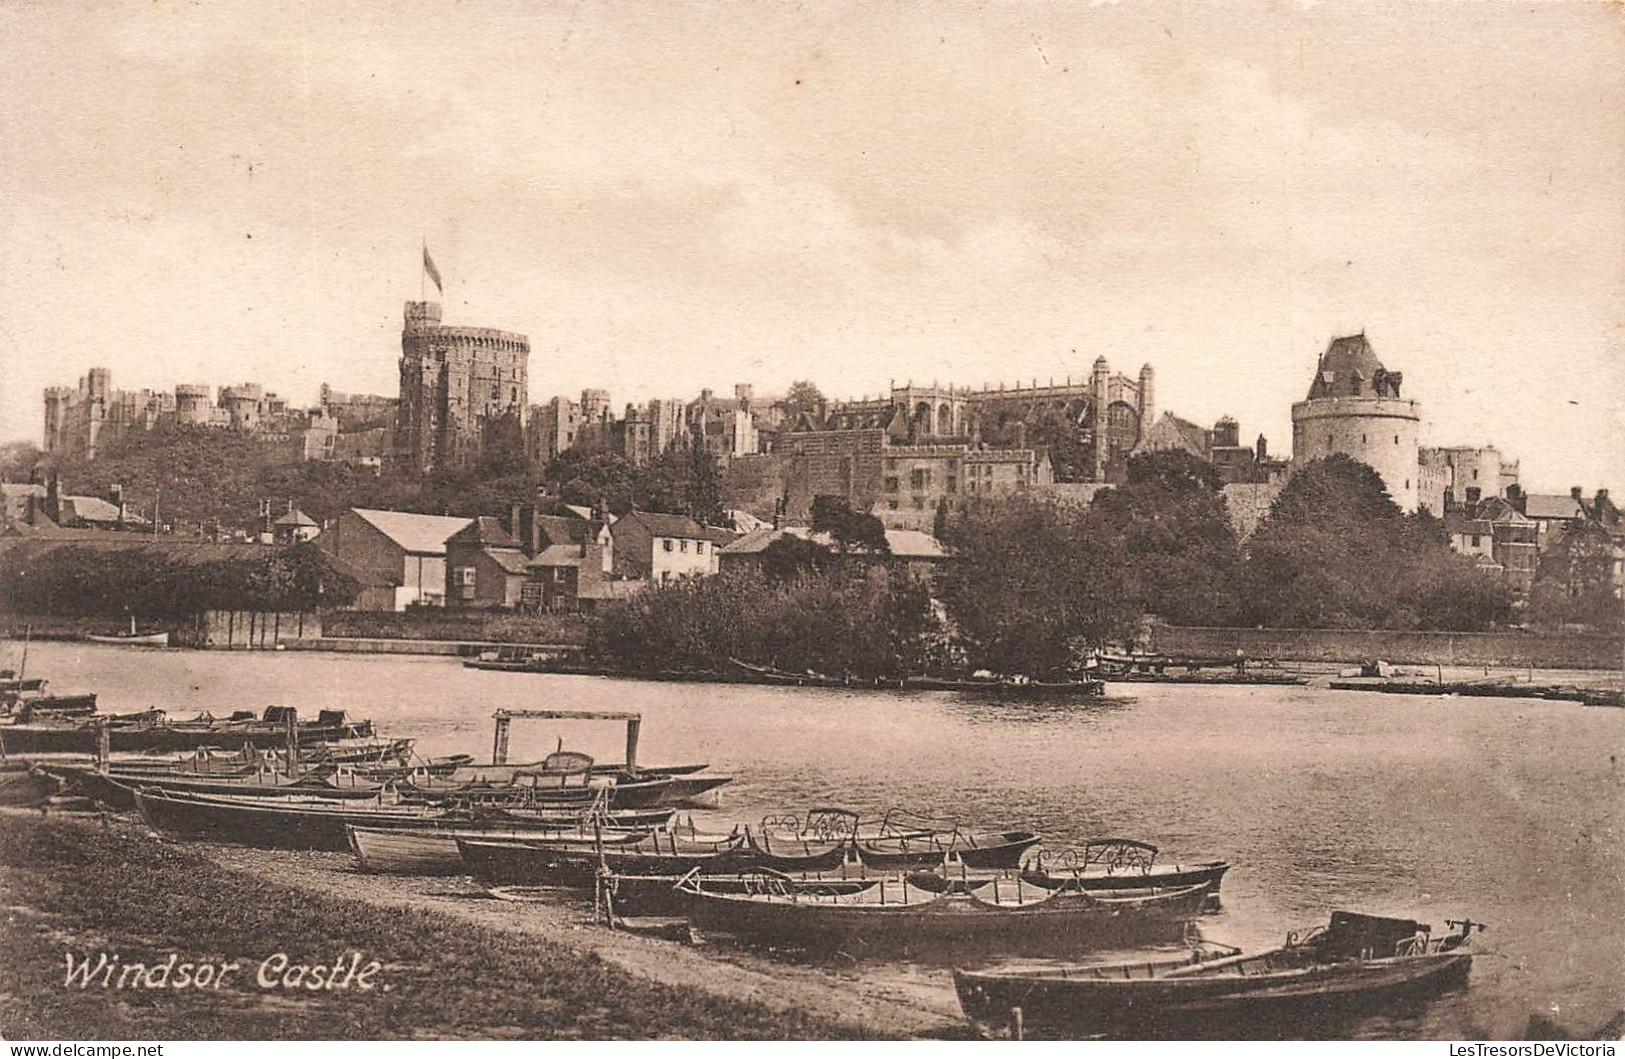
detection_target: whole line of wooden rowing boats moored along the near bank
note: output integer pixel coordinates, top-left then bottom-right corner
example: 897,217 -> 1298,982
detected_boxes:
0,691 -> 1482,1036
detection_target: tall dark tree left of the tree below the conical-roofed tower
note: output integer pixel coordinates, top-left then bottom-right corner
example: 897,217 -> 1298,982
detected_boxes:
1089,450 -> 1242,625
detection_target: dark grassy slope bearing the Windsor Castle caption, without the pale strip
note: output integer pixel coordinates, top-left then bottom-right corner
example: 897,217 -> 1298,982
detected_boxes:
0,812 -> 873,1040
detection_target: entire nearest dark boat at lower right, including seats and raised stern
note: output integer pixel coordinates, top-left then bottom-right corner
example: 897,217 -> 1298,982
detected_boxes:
954,911 -> 1482,1038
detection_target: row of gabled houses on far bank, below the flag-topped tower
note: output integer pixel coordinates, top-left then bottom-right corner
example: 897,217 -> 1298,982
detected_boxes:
315,504 -> 946,612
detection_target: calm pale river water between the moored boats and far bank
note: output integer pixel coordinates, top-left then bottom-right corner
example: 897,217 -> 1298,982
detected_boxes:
7,643 -> 1625,1038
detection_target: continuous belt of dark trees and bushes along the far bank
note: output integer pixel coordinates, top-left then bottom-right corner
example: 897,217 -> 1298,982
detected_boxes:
590,452 -> 1547,677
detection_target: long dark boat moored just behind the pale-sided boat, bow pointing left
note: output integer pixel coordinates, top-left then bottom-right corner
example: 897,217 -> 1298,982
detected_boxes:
135,786 -> 676,851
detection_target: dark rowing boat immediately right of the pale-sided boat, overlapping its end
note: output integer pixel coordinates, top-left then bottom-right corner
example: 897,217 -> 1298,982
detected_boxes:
457,832 -> 751,888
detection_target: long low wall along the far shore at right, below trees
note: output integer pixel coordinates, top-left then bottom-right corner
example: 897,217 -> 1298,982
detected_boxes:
1151,625 -> 1625,669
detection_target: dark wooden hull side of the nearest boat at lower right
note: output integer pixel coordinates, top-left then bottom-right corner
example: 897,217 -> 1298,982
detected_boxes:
954,952 -> 1472,1036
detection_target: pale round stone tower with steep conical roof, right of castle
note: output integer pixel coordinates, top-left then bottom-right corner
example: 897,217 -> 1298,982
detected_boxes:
1292,333 -> 1422,512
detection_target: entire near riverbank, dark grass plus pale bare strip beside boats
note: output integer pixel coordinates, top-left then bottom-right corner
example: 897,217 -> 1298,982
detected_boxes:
0,810 -> 962,1040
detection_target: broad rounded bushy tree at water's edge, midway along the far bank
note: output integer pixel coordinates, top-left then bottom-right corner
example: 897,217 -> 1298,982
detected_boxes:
938,495 -> 1139,677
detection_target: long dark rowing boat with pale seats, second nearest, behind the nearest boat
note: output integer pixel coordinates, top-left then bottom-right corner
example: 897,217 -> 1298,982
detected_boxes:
683,875 -> 1207,958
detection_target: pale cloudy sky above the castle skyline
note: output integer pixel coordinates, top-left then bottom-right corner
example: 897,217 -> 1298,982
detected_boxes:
0,0 -> 1625,492
